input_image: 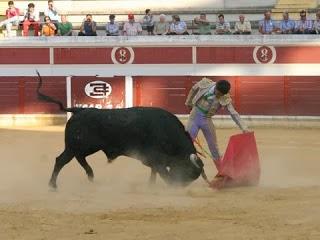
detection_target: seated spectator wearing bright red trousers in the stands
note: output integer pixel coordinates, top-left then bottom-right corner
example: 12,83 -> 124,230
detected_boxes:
23,3 -> 40,36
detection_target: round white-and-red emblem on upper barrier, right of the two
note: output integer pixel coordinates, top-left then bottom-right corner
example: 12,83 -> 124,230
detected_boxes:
253,46 -> 277,64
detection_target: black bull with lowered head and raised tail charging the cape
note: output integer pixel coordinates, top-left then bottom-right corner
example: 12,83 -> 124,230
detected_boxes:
37,72 -> 205,188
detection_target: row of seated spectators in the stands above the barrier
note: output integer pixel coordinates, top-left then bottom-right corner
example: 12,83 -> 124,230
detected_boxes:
0,0 -> 320,36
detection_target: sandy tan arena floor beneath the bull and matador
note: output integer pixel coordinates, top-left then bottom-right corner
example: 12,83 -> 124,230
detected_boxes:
0,127 -> 320,240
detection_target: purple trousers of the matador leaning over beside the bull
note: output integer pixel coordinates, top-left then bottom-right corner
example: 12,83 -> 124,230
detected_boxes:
186,107 -> 221,161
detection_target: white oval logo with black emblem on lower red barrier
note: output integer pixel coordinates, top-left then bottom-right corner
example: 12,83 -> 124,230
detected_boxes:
84,81 -> 112,98
